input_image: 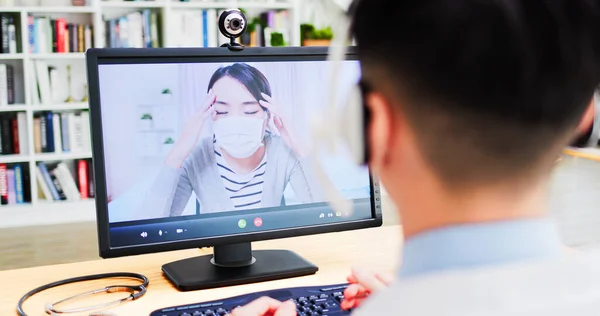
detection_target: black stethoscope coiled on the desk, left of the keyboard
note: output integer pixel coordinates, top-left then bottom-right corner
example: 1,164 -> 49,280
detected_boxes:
17,272 -> 150,316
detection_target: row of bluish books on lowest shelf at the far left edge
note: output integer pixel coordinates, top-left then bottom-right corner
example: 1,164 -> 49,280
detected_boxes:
0,163 -> 31,205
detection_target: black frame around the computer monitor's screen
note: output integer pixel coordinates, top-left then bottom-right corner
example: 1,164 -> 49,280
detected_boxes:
86,47 -> 383,258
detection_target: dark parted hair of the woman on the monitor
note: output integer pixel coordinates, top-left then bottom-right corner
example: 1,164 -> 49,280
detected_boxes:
208,63 -> 271,112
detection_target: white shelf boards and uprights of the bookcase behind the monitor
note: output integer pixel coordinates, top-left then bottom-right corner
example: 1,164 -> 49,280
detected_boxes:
0,0 -> 301,228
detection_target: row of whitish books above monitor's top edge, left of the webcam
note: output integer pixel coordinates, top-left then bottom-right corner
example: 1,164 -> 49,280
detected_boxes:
105,9 -> 161,48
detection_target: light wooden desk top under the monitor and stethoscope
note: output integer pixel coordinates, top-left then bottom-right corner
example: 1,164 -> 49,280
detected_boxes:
0,226 -> 402,316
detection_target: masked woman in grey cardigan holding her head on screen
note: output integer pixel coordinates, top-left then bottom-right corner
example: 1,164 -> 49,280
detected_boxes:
142,63 -> 315,217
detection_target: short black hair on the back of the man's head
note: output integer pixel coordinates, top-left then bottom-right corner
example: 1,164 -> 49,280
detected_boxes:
350,0 -> 600,185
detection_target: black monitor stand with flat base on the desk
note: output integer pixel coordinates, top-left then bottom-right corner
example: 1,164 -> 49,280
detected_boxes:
162,243 -> 319,291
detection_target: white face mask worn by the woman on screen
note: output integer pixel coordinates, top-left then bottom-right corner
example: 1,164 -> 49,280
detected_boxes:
213,116 -> 264,158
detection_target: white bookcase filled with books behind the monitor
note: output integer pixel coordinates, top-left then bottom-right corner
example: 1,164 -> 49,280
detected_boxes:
0,0 -> 301,228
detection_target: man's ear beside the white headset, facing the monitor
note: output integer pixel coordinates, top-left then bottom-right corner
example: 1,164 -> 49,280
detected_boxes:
366,92 -> 394,172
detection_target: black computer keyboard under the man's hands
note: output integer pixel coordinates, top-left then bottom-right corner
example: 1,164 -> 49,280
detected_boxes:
150,284 -> 350,316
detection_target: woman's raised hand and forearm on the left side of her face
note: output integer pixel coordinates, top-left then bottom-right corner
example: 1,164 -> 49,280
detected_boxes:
166,89 -> 217,168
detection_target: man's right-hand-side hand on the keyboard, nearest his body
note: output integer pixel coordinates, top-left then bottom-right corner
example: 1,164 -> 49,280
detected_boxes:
340,269 -> 392,310
